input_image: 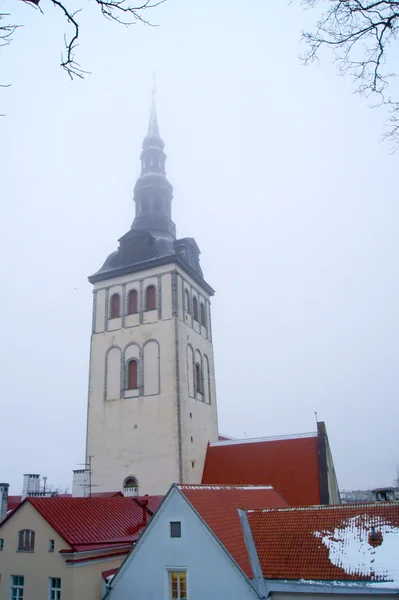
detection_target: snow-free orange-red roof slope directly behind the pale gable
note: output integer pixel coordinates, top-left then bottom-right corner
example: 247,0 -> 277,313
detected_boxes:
177,485 -> 287,577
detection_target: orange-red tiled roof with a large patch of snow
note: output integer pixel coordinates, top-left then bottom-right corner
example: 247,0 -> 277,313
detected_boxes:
247,502 -> 399,581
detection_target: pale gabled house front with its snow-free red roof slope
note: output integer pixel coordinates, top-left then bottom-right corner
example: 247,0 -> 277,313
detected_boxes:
104,485 -> 286,600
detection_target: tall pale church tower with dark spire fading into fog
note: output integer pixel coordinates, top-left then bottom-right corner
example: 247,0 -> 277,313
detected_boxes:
86,98 -> 218,495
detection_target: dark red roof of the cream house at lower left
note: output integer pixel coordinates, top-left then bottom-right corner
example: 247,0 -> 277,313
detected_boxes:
11,495 -> 150,550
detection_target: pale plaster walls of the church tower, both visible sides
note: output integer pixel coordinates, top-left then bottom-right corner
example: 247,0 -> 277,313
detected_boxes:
86,264 -> 218,494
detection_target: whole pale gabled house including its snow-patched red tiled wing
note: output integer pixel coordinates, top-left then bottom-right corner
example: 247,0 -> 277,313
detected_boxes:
103,484 -> 399,600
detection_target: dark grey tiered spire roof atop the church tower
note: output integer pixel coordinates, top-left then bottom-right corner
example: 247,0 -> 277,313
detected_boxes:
89,95 -> 213,294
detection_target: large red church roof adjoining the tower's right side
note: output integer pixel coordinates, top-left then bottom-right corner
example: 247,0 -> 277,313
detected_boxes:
202,433 -> 320,506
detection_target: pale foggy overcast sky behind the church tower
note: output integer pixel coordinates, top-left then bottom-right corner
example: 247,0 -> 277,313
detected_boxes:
0,0 -> 399,494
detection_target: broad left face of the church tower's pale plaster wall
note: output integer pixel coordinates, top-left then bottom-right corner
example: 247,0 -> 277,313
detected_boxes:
87,265 -> 179,494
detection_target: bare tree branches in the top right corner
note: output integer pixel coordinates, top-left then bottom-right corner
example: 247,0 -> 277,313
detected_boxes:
302,0 -> 399,150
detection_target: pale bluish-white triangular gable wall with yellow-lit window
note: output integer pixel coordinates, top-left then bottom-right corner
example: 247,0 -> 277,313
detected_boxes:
107,491 -> 258,600
